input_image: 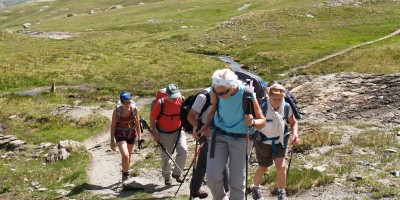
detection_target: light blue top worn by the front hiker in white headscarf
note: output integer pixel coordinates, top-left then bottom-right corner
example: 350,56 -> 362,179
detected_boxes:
214,82 -> 256,134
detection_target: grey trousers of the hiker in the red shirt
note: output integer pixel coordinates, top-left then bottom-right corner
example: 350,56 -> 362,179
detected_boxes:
159,131 -> 187,179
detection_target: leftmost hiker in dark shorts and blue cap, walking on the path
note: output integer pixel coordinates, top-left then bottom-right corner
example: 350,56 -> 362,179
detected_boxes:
110,92 -> 141,181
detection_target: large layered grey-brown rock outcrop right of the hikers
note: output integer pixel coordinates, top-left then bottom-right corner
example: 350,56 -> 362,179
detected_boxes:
284,73 -> 400,126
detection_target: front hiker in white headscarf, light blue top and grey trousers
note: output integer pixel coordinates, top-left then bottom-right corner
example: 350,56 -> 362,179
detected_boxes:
201,69 -> 266,200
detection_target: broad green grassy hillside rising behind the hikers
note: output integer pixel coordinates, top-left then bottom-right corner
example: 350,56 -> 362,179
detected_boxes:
0,0 -> 400,94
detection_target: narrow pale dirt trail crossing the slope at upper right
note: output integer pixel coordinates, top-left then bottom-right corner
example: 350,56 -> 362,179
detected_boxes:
291,29 -> 400,71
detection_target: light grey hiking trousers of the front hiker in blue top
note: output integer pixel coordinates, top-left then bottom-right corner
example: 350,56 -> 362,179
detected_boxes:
206,133 -> 253,200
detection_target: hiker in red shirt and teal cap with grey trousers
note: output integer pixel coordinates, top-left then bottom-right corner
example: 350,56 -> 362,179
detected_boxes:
150,84 -> 188,185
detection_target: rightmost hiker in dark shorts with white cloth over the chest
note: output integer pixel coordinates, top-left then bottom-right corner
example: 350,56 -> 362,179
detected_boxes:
252,84 -> 299,200
